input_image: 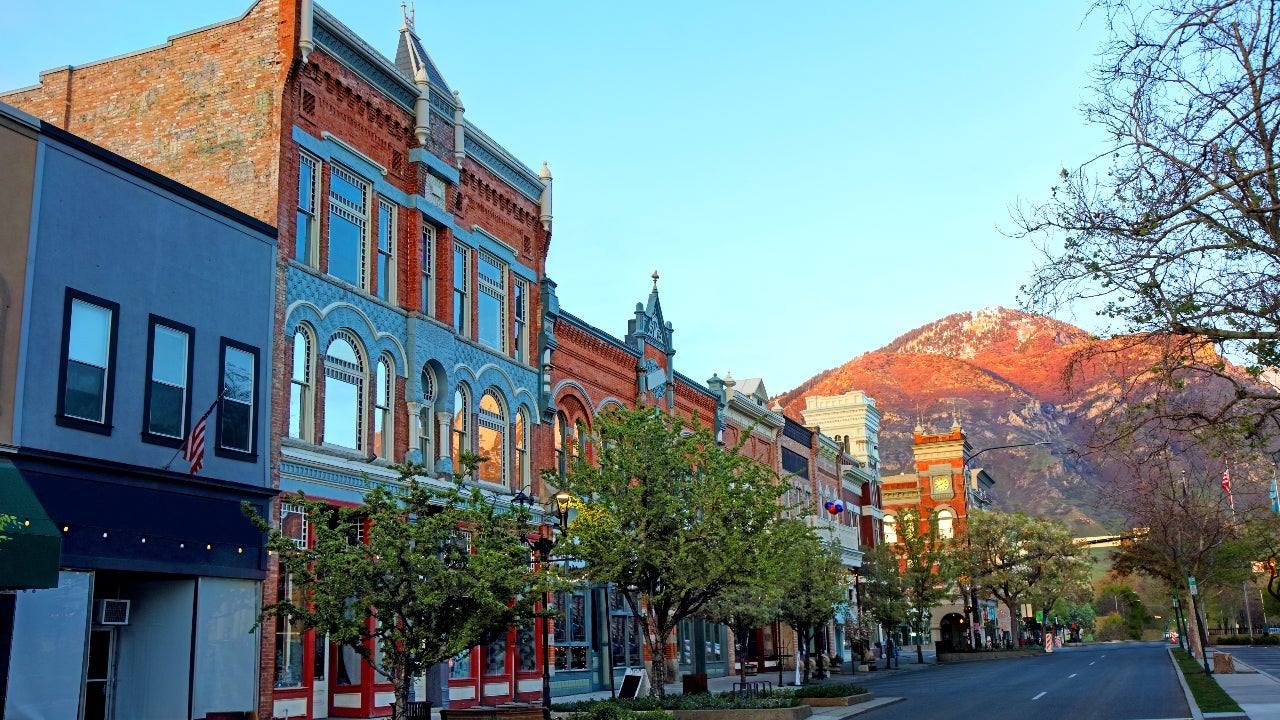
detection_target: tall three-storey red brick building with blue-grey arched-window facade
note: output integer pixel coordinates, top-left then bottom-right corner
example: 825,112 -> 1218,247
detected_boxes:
0,0 -> 552,717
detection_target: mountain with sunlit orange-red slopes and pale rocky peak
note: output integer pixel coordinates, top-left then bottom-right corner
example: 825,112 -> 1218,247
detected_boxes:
778,307 -> 1143,534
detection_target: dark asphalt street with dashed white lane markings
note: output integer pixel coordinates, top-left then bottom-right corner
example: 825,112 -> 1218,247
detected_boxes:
854,642 -> 1190,720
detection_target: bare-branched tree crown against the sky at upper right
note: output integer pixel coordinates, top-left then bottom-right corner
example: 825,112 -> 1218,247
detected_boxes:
1014,0 -> 1280,445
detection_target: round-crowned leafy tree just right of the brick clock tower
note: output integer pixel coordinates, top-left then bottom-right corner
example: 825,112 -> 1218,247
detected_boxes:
957,511 -> 1091,642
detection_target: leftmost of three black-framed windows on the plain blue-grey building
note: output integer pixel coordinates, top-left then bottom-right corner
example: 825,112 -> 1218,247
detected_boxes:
58,288 -> 120,434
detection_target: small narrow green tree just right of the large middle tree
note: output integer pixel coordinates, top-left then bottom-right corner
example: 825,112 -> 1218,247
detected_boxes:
780,519 -> 845,683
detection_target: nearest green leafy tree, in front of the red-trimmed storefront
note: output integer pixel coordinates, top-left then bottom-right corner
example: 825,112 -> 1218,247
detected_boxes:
244,456 -> 544,719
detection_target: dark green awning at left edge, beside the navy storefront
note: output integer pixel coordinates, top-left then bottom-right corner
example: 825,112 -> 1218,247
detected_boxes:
0,460 -> 63,589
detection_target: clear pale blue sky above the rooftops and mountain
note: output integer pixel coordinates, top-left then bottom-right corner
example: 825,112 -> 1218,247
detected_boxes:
0,0 -> 1102,393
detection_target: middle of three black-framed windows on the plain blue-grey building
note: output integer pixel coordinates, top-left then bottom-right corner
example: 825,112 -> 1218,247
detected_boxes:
142,315 -> 195,447
